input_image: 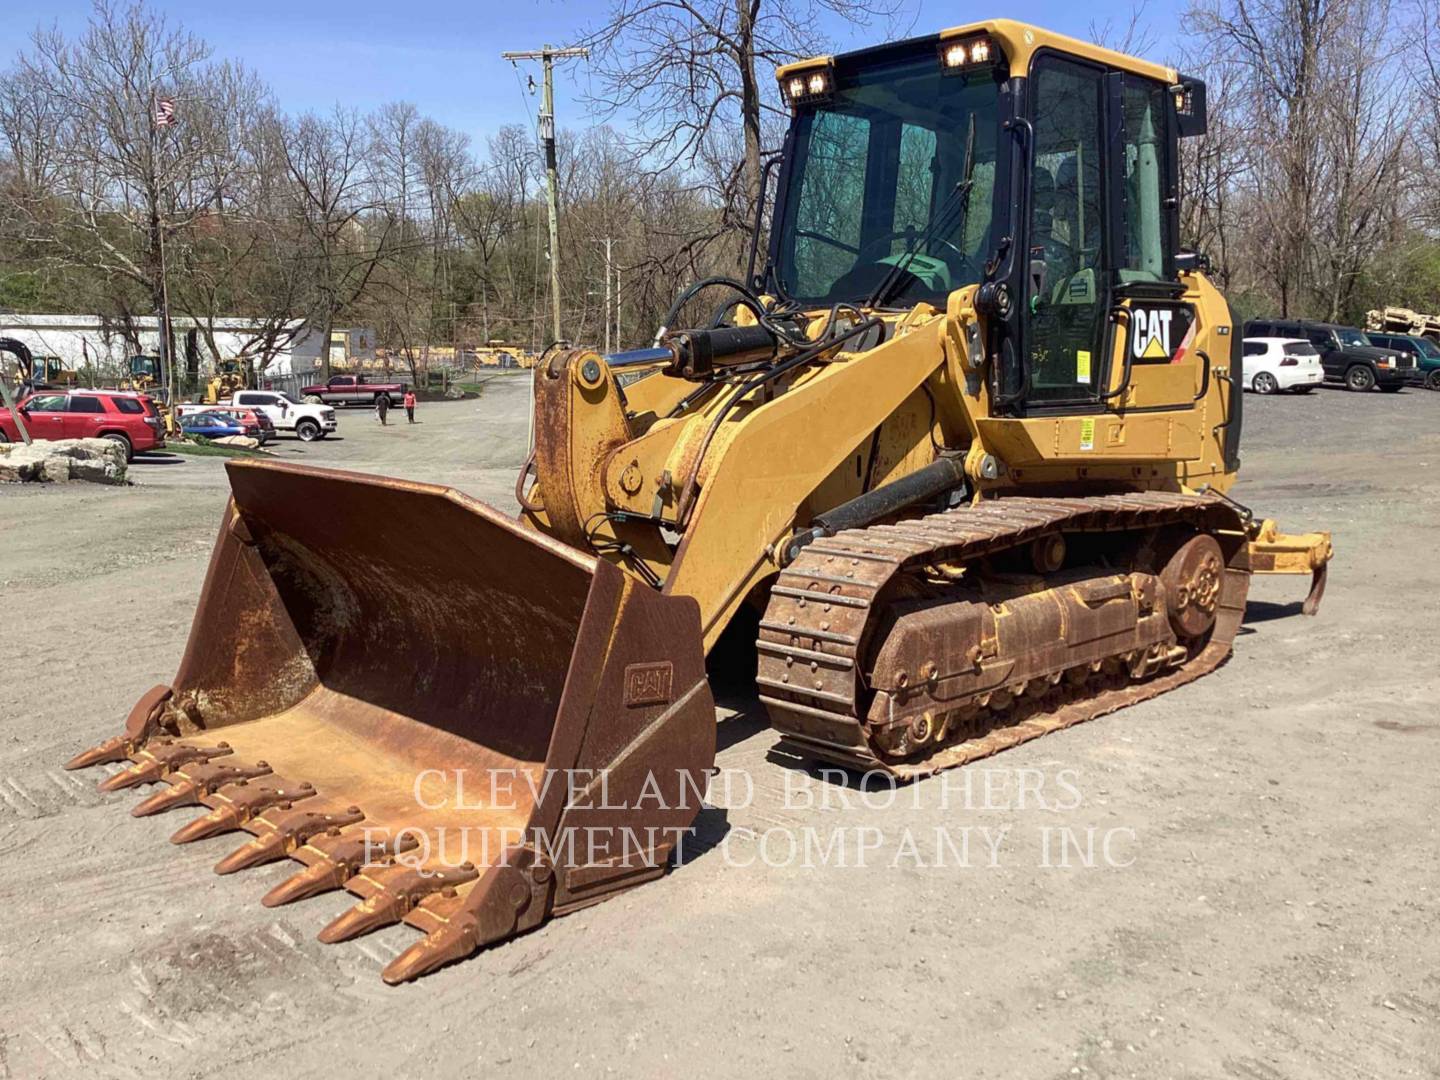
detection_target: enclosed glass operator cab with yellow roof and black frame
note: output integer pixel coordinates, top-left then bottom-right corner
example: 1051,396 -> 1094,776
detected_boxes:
755,20 -> 1228,416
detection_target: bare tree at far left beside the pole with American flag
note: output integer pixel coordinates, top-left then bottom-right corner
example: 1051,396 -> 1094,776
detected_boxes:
3,0 -> 266,397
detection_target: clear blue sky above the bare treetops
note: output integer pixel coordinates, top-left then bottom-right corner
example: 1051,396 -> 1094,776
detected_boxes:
0,0 -> 1182,143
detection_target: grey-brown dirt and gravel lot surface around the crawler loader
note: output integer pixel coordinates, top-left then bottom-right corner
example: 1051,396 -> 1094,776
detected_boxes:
0,377 -> 1440,1080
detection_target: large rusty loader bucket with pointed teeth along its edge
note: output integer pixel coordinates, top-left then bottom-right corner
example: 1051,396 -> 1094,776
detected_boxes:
68,462 -> 714,982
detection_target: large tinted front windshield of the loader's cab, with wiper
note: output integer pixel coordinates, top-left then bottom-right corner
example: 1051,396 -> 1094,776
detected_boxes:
776,48 -> 998,304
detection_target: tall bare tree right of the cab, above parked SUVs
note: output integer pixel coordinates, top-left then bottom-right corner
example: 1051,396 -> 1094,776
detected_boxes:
1189,0 -> 1411,320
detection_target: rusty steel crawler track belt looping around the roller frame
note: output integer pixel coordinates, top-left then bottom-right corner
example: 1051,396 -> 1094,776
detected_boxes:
756,491 -> 1250,779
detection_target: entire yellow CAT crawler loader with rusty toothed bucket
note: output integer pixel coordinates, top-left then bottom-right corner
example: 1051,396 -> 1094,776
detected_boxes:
68,19 -> 1331,982
